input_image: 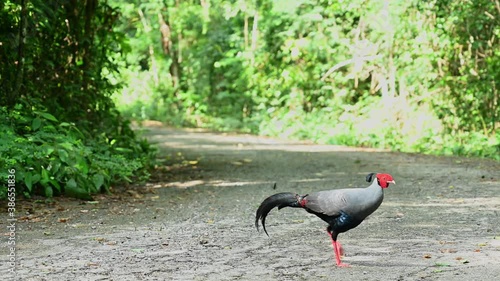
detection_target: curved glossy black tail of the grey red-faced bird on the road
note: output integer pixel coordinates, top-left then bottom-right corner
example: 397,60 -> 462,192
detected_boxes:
255,188 -> 307,236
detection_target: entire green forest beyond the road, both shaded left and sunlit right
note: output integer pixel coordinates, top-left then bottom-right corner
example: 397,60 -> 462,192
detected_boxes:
0,0 -> 500,199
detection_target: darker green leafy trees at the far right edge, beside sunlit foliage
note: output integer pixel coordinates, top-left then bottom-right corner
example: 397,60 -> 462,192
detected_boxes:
435,0 -> 500,136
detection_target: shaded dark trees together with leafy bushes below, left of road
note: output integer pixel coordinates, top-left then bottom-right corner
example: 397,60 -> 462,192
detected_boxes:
0,0 -> 154,199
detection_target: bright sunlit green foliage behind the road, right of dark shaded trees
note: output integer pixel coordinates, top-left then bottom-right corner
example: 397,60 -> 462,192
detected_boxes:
113,0 -> 500,158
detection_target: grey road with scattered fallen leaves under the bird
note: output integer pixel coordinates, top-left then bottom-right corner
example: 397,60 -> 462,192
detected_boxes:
0,127 -> 500,281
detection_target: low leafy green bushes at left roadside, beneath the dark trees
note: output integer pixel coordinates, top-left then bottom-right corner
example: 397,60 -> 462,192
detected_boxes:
0,106 -> 153,200
